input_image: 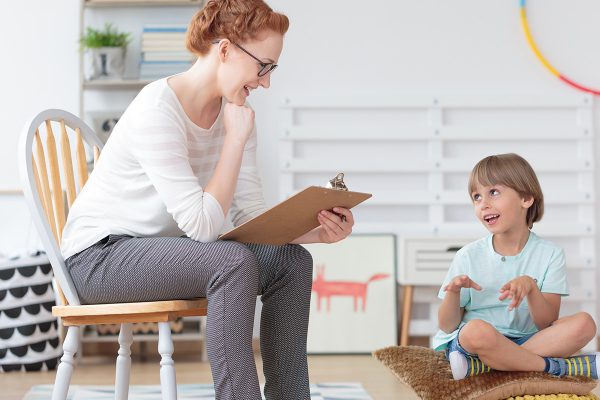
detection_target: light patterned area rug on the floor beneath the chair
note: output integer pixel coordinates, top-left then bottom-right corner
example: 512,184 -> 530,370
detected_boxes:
23,382 -> 372,400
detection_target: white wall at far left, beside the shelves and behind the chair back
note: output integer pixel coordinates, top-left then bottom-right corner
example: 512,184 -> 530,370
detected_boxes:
0,0 -> 79,254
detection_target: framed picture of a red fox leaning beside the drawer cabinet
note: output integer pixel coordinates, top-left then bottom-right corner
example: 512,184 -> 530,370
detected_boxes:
305,234 -> 398,353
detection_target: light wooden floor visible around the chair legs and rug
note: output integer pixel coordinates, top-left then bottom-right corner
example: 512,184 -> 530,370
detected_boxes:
0,355 -> 418,400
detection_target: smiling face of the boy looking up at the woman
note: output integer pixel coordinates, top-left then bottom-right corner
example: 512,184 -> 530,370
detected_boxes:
471,184 -> 533,234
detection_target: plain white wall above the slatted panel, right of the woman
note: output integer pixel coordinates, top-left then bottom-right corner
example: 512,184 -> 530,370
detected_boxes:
251,0 -> 600,206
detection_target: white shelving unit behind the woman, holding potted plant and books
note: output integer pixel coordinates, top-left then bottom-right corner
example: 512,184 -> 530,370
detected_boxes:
79,0 -> 206,360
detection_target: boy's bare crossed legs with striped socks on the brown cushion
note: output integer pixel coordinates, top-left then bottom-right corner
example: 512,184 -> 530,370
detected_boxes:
448,312 -> 600,379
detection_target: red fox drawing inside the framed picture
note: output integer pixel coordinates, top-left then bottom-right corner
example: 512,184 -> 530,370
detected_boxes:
312,264 -> 390,312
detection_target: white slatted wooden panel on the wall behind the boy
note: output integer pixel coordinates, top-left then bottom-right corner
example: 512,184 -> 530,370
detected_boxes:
279,93 -> 597,350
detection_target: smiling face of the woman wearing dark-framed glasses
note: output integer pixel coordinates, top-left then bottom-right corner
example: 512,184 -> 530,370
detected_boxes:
219,31 -> 283,106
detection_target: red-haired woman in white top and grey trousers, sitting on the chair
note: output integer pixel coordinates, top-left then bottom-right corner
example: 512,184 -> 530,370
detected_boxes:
62,0 -> 353,400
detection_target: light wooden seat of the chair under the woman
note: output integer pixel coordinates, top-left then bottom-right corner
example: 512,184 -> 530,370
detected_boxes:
52,298 -> 208,326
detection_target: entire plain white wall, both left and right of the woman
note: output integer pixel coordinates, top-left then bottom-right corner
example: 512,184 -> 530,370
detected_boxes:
0,0 -> 600,253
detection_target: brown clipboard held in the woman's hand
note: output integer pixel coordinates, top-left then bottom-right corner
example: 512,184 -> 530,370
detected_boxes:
219,186 -> 372,245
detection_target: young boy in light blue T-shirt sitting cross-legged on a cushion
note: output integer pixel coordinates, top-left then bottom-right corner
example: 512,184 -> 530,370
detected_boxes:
434,154 -> 600,380
